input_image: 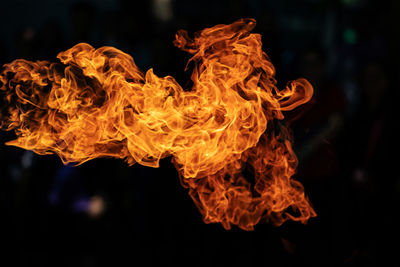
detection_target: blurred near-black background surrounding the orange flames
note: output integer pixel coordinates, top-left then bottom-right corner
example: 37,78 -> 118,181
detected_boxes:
0,0 -> 400,267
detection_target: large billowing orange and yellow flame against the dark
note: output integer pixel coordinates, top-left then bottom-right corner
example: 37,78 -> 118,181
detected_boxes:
0,19 -> 316,230
